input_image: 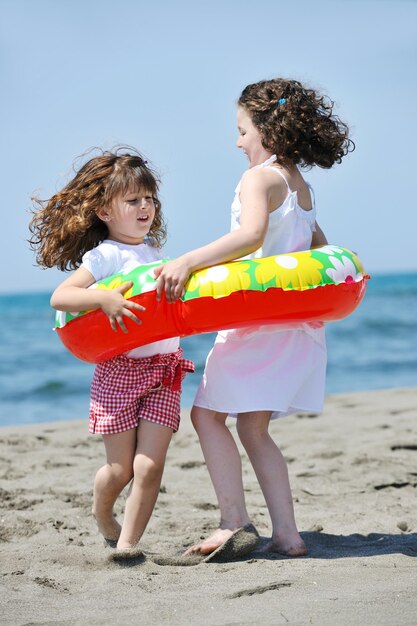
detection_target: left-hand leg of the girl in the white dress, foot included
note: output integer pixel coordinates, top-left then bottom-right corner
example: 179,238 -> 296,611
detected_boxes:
185,407 -> 250,554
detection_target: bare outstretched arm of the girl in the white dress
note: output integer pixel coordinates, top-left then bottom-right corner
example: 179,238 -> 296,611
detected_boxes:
155,170 -> 275,302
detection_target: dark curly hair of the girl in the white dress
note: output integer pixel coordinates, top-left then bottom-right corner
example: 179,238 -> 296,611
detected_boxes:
238,78 -> 355,168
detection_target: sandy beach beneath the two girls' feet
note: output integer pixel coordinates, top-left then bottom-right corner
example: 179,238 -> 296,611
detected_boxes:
0,388 -> 417,626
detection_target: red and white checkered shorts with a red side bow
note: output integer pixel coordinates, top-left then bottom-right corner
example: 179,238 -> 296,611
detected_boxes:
89,348 -> 194,435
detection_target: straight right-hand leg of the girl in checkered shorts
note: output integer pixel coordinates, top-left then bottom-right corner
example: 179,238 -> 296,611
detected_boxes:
117,420 -> 172,550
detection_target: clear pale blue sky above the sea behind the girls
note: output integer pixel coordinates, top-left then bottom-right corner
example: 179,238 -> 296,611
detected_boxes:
0,0 -> 417,293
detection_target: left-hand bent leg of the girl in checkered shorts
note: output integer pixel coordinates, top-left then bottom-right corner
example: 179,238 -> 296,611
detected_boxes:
93,428 -> 136,540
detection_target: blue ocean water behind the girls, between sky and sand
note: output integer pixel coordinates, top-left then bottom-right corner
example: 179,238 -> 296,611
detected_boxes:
0,274 -> 417,425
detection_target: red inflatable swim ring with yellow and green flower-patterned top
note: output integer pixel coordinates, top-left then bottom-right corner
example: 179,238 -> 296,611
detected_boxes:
56,245 -> 369,363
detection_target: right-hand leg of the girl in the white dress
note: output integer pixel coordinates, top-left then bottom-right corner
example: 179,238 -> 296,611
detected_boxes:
237,411 -> 307,556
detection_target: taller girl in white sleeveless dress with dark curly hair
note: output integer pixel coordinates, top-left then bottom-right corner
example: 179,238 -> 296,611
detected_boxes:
154,78 -> 354,559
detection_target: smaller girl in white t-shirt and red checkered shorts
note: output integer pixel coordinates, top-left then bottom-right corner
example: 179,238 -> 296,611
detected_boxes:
30,150 -> 194,561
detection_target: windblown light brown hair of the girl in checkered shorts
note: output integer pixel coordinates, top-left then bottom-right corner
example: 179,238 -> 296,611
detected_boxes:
29,147 -> 166,271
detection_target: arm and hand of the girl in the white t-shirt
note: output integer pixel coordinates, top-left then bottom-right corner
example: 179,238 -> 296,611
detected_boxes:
51,267 -> 145,333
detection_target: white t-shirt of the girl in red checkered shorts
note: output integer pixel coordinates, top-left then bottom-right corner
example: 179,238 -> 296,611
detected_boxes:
81,239 -> 180,359
